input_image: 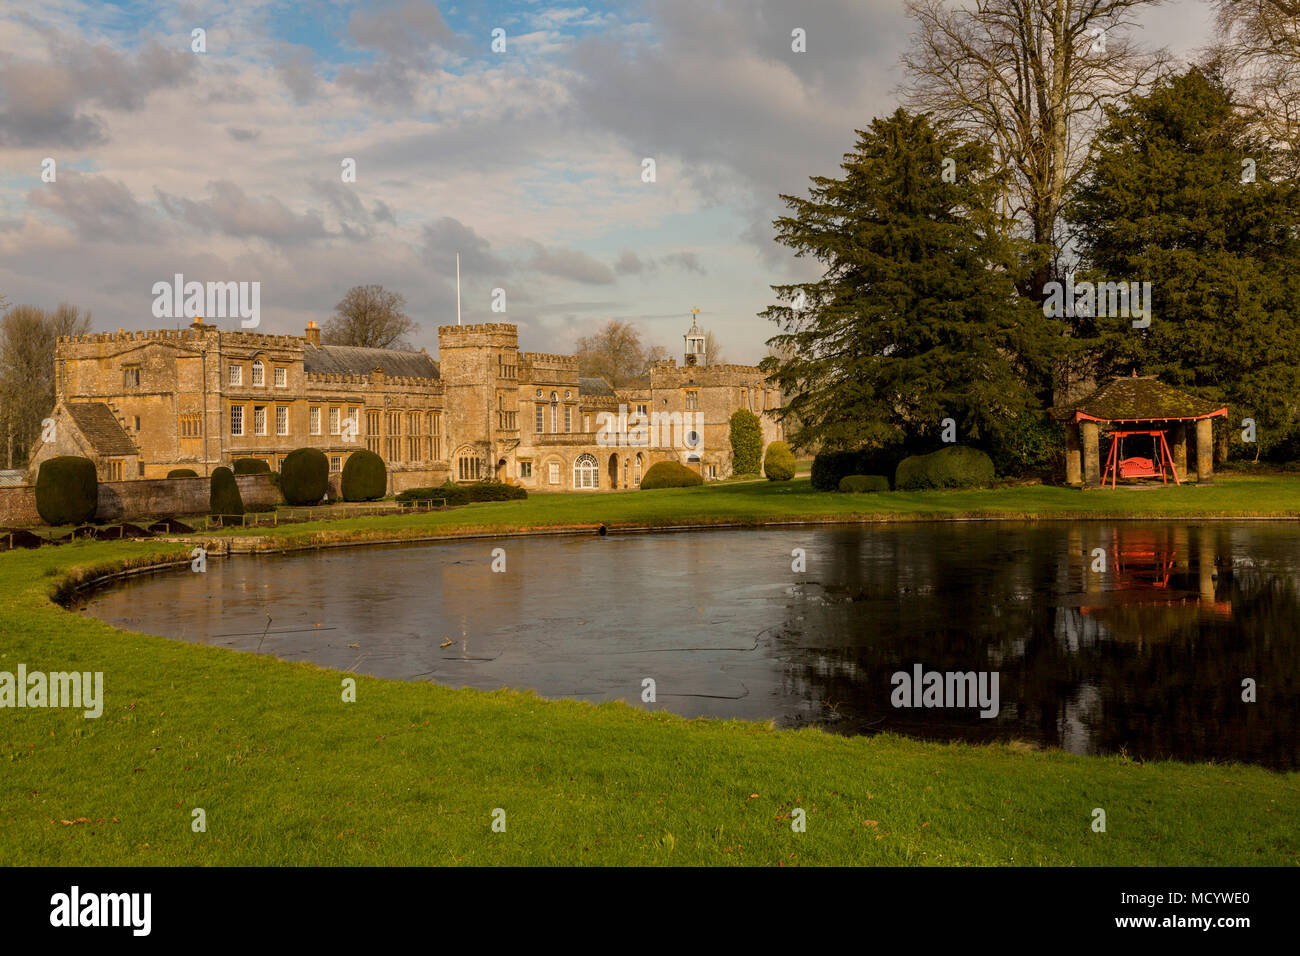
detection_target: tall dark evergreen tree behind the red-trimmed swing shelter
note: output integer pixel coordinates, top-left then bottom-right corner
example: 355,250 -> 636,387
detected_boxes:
1066,69 -> 1300,453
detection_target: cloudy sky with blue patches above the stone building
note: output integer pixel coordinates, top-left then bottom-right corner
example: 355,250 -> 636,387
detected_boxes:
0,0 -> 1210,362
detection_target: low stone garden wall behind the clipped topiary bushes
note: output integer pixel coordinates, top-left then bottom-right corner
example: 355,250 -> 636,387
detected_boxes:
0,475 -> 281,528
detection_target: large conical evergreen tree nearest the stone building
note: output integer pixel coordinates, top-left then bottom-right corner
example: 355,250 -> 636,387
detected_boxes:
762,109 -> 1060,460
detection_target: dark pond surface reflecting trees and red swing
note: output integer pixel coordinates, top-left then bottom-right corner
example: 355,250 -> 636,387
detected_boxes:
78,523 -> 1300,767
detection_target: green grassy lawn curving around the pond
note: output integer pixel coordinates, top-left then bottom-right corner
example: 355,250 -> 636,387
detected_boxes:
0,477 -> 1300,865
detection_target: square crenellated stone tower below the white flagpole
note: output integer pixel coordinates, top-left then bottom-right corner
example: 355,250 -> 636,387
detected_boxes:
438,323 -> 519,481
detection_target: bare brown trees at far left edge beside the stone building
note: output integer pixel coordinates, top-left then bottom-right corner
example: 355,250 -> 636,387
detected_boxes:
0,303 -> 90,467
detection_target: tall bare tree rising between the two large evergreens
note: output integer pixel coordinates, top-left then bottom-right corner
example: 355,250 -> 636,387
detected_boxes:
902,0 -> 1166,298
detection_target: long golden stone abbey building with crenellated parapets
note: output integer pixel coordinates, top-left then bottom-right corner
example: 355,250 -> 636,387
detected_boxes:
29,319 -> 783,492
